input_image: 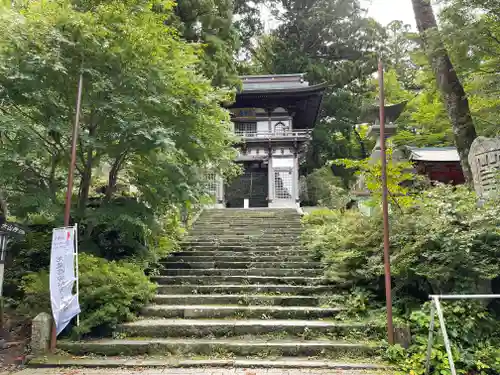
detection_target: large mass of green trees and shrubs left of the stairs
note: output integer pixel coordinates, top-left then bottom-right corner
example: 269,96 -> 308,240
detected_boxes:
0,0 -> 238,333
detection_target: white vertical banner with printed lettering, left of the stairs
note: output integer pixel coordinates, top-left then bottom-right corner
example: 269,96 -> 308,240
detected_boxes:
50,226 -> 80,335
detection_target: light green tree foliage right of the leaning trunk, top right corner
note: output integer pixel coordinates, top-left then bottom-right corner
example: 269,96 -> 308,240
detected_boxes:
440,0 -> 500,136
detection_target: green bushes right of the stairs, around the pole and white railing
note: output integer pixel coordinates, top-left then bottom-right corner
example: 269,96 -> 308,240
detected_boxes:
303,186 -> 500,375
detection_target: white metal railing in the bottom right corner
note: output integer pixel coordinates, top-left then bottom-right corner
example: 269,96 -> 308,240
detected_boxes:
425,294 -> 500,375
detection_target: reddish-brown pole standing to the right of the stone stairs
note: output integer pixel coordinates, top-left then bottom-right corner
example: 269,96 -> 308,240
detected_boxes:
378,60 -> 394,345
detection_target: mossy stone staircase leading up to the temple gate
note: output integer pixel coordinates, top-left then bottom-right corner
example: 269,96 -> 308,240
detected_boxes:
52,209 -> 383,368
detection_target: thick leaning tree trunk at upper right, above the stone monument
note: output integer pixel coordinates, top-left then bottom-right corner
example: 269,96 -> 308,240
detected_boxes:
412,0 -> 477,184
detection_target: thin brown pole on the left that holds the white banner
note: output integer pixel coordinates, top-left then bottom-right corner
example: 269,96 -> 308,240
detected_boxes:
50,72 -> 83,351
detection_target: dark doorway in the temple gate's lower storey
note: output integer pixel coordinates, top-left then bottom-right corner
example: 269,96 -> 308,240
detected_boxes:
225,161 -> 269,208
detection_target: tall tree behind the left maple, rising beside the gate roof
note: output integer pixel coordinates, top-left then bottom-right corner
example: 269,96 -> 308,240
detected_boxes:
67,0 -> 262,87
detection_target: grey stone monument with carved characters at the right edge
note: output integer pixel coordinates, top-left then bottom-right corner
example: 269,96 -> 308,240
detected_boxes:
469,137 -> 500,198
